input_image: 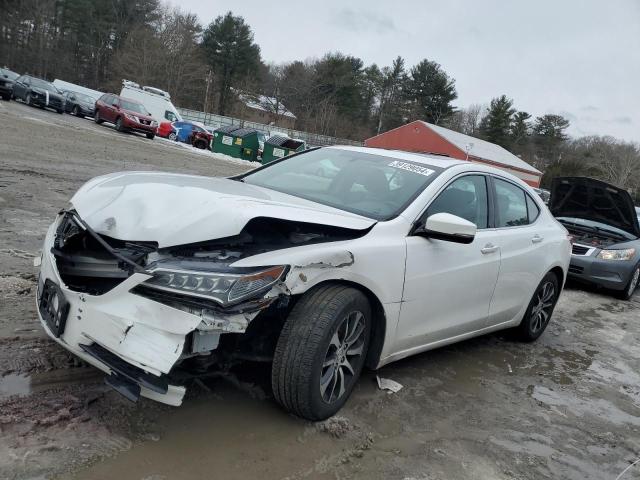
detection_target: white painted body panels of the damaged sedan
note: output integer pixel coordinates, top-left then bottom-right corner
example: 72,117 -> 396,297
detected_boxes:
36,147 -> 570,405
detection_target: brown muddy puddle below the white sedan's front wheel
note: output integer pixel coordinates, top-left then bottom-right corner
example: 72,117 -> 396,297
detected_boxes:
65,388 -> 360,480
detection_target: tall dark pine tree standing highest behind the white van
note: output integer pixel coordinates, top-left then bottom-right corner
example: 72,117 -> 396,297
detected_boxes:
202,12 -> 261,115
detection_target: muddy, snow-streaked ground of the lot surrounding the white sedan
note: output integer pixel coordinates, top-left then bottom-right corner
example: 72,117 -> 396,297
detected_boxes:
0,102 -> 640,480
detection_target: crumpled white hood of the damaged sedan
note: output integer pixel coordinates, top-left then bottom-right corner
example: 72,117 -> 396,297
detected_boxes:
71,172 -> 376,248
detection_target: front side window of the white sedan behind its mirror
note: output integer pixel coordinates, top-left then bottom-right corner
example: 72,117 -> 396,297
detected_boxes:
424,175 -> 489,229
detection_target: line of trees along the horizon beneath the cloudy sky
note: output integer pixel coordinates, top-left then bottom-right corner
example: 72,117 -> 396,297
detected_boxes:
0,0 -> 640,198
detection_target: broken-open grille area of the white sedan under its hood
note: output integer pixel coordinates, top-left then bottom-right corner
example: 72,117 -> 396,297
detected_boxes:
51,214 -> 156,295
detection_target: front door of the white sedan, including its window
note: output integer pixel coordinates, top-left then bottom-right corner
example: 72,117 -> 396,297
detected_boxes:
396,174 -> 500,352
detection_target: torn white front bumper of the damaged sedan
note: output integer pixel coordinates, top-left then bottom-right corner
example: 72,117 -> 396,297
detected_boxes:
37,214 -> 279,406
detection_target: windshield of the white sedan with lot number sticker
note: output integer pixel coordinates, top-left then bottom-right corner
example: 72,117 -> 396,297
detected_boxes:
242,148 -> 442,220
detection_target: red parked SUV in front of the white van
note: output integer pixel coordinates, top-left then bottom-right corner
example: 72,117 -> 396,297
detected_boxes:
94,93 -> 158,139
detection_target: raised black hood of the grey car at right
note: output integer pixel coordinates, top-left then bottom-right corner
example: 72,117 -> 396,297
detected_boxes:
549,177 -> 640,237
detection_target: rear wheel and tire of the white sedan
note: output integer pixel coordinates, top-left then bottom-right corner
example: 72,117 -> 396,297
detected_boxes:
516,272 -> 560,342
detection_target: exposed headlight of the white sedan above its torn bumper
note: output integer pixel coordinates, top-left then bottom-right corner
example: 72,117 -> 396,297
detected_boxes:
144,266 -> 286,305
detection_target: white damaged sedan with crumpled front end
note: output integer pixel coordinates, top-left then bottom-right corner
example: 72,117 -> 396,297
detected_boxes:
38,147 -> 571,420
